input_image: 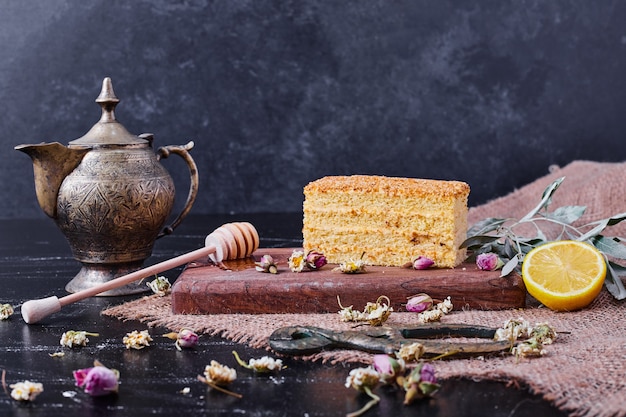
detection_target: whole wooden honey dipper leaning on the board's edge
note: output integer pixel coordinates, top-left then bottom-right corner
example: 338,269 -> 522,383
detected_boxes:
22,222 -> 259,324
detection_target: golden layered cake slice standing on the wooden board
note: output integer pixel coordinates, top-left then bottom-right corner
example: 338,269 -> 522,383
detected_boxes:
302,175 -> 469,267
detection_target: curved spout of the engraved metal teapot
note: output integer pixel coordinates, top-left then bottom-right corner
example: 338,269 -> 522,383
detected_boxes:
15,142 -> 89,219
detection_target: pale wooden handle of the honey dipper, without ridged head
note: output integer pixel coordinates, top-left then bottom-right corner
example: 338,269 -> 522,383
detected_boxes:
21,246 -> 216,324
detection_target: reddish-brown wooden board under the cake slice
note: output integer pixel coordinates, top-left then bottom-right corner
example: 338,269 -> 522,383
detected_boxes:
172,248 -> 526,314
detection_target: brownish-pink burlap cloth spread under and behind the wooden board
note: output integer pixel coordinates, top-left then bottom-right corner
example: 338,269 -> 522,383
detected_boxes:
103,161 -> 626,416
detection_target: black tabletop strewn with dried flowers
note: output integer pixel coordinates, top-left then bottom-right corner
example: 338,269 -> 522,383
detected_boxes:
0,213 -> 563,417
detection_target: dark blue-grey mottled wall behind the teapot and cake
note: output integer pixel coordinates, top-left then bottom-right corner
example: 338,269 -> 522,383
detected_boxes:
0,0 -> 626,217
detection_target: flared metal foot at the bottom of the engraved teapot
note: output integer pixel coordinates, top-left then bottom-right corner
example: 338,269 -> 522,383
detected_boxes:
65,261 -> 150,297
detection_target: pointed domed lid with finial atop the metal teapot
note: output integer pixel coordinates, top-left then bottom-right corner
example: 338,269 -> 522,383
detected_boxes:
69,77 -> 148,147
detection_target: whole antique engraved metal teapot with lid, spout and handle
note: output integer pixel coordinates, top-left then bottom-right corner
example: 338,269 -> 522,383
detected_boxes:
15,77 -> 198,296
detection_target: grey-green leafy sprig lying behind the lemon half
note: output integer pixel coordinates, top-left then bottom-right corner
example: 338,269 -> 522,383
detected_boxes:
461,177 -> 626,300
